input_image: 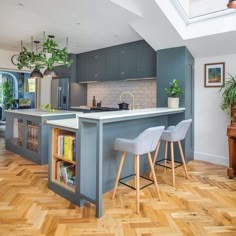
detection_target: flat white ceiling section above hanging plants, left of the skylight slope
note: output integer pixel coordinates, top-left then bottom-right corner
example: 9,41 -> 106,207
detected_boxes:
0,0 -> 141,53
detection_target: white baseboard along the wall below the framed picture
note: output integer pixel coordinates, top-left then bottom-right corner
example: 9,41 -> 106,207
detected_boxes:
194,152 -> 229,166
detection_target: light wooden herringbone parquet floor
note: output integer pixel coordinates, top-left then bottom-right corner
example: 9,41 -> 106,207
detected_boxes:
0,135 -> 236,236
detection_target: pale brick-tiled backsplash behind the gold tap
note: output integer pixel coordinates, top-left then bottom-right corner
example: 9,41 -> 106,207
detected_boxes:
87,80 -> 156,108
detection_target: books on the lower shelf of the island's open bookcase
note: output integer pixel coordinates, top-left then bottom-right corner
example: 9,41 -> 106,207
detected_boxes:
55,160 -> 75,187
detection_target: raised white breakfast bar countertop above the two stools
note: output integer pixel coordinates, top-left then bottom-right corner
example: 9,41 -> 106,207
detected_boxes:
78,107 -> 185,120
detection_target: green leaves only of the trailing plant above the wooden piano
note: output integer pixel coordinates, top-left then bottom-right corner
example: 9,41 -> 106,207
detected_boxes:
220,74 -> 236,112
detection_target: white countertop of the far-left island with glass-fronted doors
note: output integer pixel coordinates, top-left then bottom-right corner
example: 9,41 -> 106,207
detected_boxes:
6,109 -> 83,117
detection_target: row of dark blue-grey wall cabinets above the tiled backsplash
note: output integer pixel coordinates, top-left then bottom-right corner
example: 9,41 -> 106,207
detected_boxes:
77,40 -> 156,82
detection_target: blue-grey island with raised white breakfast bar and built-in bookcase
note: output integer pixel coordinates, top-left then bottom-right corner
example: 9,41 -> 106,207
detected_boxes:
48,108 -> 193,217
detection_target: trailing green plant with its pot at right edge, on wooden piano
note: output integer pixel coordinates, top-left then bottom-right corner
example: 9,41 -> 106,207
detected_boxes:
220,74 -> 236,126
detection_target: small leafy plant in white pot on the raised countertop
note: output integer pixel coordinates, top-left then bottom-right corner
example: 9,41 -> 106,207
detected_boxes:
165,79 -> 183,108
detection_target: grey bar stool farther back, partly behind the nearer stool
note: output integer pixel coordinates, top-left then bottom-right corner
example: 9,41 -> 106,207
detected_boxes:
152,119 -> 192,187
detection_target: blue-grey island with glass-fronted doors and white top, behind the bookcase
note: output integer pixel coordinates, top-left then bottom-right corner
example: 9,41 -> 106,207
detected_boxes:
6,109 -> 82,165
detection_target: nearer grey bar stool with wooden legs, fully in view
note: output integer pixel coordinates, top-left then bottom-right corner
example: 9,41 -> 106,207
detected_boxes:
112,126 -> 165,214
